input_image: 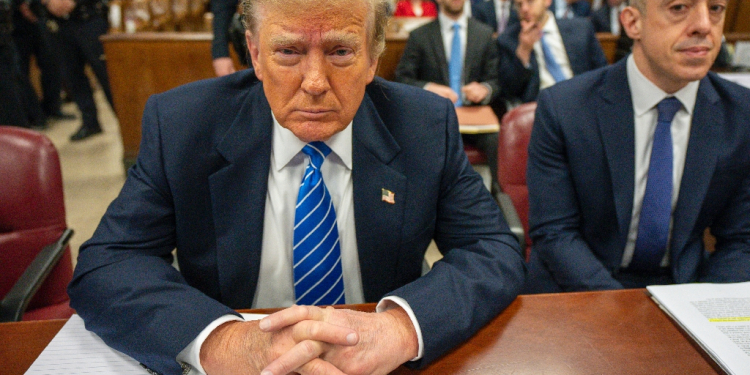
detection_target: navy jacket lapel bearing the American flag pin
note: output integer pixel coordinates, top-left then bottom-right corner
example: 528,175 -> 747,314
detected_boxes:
352,91 -> 408,301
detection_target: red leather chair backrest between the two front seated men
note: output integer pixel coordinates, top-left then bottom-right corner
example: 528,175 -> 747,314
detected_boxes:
497,102 -> 536,258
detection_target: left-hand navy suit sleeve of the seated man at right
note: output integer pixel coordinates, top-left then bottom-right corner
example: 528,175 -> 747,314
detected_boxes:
526,90 -> 622,291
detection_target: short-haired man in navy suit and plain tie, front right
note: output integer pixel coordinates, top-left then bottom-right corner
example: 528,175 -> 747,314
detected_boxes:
526,0 -> 750,292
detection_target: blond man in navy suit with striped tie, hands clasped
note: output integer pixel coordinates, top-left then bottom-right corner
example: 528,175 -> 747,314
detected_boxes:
69,0 -> 525,375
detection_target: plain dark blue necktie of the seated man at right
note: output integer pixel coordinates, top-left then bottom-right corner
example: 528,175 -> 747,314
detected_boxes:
629,97 -> 682,271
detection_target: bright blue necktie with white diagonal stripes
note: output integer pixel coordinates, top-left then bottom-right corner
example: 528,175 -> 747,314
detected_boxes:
293,142 -> 344,305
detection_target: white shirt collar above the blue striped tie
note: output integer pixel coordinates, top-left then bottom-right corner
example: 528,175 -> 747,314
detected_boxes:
271,113 -> 353,170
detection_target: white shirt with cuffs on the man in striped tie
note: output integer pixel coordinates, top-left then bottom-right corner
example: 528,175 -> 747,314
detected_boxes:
177,116 -> 424,375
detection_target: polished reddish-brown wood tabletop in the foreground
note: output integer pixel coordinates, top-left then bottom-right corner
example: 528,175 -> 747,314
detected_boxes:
0,289 -> 723,375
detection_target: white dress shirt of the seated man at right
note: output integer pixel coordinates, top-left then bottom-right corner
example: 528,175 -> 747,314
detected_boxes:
621,55 -> 700,268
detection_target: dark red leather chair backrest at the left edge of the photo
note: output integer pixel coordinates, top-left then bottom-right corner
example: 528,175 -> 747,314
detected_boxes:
0,126 -> 73,320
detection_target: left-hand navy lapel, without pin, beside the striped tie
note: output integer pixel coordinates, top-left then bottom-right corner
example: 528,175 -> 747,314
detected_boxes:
209,83 -> 273,308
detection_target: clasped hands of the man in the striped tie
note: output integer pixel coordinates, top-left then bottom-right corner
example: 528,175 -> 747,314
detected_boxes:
200,306 -> 419,375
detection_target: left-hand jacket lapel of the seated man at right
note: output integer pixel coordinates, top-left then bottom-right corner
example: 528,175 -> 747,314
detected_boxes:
596,59 -> 635,242
